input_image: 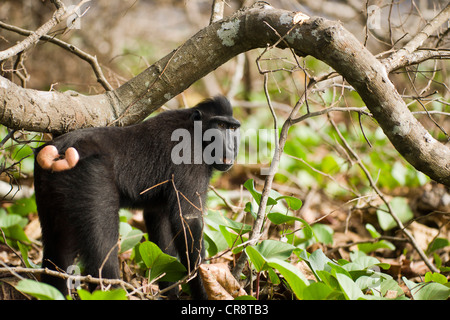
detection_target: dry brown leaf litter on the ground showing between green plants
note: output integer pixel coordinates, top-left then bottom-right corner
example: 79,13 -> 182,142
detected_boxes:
0,172 -> 450,299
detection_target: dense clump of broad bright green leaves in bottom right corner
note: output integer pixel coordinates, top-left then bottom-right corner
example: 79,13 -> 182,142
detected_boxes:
246,245 -> 450,300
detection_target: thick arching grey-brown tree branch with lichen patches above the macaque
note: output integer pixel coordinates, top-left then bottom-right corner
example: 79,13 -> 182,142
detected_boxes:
0,5 -> 450,186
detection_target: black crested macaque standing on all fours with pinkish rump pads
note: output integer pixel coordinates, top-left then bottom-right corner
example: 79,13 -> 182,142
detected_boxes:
34,96 -> 240,299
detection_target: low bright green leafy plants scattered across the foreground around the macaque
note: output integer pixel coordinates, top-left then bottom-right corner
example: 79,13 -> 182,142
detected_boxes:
0,172 -> 450,300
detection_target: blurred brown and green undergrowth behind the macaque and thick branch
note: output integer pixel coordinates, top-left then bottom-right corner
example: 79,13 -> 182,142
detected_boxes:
0,0 -> 450,300
